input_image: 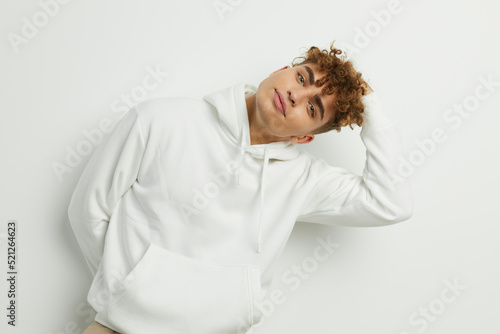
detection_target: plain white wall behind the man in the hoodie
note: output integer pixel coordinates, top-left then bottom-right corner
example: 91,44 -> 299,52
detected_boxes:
0,0 -> 500,334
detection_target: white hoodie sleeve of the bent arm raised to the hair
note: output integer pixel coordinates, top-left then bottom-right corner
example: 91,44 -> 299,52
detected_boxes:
298,93 -> 413,227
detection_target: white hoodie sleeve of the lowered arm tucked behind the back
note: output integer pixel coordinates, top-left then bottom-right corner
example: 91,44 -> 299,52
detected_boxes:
68,108 -> 145,274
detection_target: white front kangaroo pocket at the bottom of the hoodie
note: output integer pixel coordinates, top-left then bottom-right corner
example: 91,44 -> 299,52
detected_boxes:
107,244 -> 262,334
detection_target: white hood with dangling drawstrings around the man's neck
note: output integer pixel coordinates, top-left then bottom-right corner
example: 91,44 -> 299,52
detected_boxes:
203,83 -> 300,253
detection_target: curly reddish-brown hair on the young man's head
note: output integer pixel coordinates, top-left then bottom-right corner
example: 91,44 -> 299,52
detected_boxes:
292,41 -> 366,134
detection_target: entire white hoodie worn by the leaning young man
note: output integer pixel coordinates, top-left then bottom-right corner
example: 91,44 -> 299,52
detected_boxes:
69,84 -> 412,334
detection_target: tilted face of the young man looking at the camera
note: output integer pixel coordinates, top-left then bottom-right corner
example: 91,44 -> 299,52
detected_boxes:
252,64 -> 335,144
